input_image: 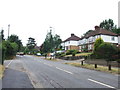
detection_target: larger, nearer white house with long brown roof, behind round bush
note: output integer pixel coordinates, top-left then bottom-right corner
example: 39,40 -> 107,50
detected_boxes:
79,26 -> 120,52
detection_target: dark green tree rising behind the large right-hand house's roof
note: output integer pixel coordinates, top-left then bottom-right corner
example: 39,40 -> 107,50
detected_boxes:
99,19 -> 116,31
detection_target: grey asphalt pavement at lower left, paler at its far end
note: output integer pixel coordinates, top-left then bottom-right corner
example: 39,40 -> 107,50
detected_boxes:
2,58 -> 33,89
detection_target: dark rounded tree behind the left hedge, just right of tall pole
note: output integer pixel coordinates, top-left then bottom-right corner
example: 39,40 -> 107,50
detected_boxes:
8,35 -> 23,51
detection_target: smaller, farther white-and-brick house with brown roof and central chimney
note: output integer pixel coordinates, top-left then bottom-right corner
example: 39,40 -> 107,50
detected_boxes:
61,33 -> 80,50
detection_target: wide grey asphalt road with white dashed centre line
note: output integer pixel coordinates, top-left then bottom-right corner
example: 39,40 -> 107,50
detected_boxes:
3,55 -> 118,89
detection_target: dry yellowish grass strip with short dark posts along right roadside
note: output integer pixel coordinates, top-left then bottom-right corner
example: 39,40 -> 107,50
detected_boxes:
64,62 -> 120,74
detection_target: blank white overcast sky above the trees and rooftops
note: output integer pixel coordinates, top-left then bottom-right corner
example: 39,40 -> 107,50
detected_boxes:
0,0 -> 119,46
